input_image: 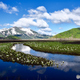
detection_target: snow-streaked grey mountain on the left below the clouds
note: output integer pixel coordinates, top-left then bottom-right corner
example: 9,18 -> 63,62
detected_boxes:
0,27 -> 49,39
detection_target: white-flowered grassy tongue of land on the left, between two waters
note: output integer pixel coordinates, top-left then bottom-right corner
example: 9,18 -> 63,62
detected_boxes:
0,43 -> 53,66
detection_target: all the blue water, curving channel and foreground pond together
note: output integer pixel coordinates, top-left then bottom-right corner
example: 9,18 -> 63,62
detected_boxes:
0,44 -> 80,80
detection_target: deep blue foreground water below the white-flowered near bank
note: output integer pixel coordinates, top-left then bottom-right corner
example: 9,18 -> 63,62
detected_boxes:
0,60 -> 80,80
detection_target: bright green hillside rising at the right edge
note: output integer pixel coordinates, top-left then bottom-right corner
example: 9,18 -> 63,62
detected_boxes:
52,28 -> 80,38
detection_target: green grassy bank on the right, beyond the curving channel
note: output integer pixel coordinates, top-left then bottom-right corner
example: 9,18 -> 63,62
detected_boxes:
24,42 -> 80,55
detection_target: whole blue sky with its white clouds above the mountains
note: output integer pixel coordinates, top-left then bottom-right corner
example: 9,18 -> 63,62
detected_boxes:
0,0 -> 80,35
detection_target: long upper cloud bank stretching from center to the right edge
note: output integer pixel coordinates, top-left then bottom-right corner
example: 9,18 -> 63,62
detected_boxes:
25,6 -> 80,26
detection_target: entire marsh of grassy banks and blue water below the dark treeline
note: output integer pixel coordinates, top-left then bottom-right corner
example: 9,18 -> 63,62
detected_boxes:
0,41 -> 80,80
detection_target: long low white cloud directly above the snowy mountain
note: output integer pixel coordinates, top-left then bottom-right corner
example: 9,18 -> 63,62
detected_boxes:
11,18 -> 49,28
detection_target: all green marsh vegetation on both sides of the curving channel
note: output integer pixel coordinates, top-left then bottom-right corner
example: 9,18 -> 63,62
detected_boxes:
0,42 -> 80,67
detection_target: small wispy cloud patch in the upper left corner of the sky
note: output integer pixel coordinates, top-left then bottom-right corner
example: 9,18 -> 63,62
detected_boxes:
0,2 -> 18,14
